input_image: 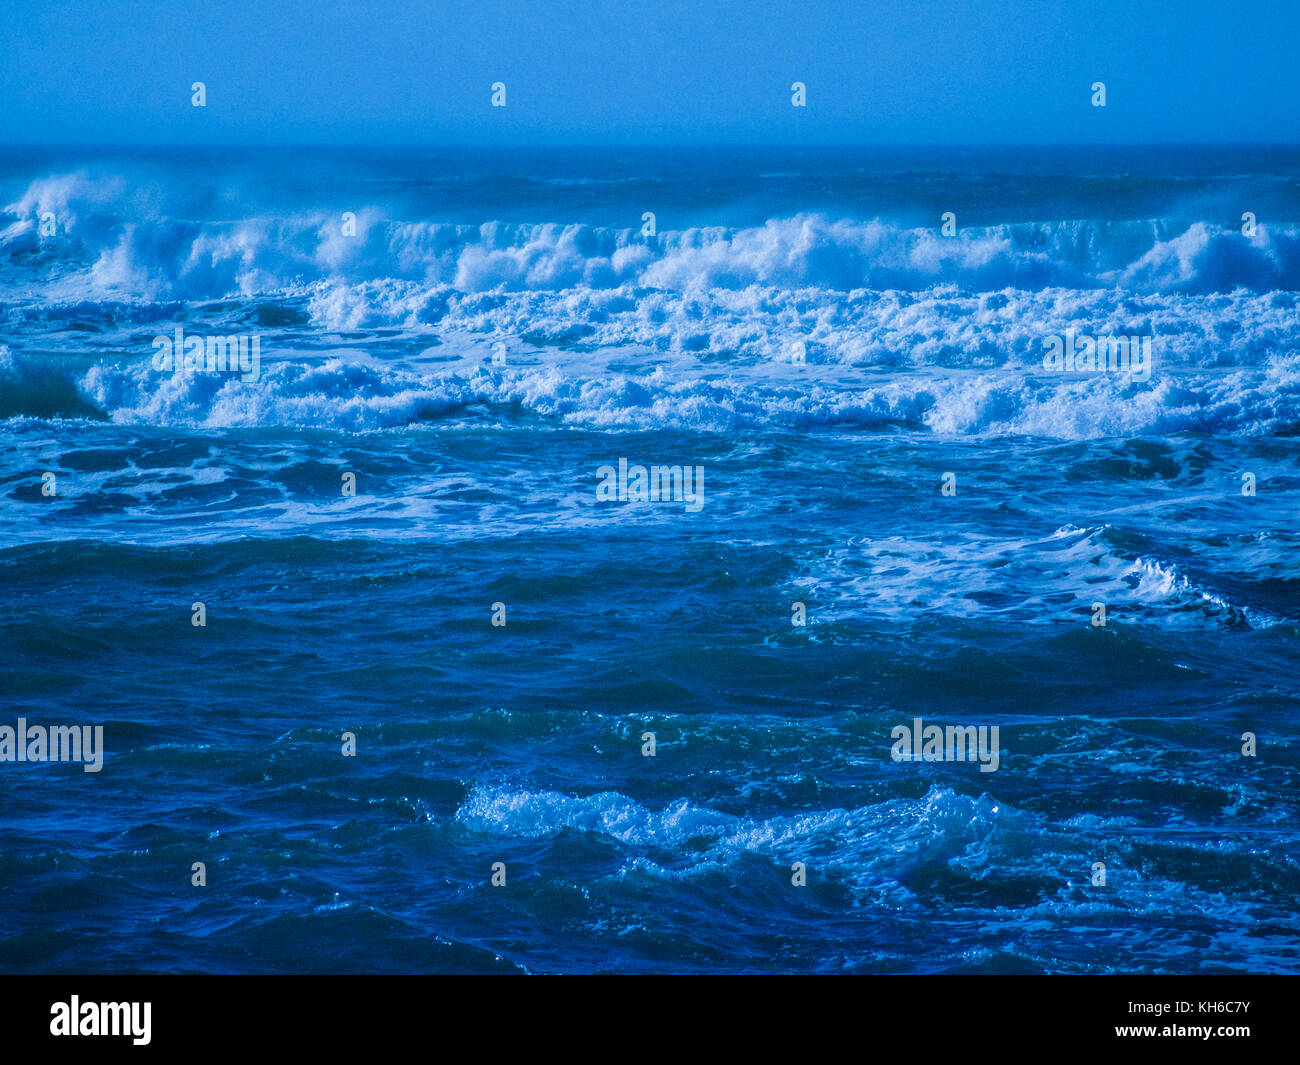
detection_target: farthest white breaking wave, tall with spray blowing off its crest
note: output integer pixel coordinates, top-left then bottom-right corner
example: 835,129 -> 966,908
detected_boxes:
0,172 -> 1300,299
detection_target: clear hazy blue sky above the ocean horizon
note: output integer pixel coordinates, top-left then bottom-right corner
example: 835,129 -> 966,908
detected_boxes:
0,0 -> 1300,146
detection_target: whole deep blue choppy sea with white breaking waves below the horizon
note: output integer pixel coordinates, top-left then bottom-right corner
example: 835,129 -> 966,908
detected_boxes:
0,148 -> 1300,973
